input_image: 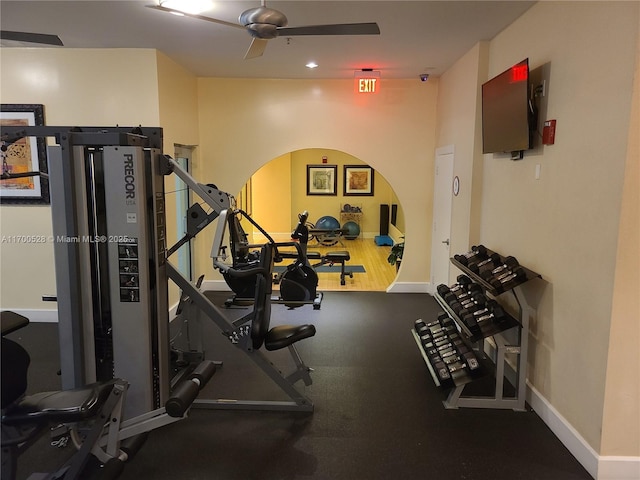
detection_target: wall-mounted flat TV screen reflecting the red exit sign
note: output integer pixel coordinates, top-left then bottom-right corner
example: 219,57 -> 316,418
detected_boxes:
482,58 -> 533,153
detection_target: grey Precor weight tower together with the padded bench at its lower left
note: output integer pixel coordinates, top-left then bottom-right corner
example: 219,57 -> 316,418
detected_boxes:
2,127 -> 220,478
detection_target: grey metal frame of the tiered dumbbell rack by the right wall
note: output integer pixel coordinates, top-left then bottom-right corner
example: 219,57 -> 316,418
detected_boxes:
424,251 -> 541,411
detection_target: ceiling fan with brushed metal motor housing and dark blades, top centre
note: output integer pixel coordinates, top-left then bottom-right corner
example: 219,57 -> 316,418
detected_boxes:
147,0 -> 380,60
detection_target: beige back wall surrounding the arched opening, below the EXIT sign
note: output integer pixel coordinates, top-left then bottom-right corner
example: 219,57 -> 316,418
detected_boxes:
197,78 -> 438,284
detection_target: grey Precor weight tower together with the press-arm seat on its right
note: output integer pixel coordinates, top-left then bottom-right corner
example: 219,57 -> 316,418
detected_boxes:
2,126 -> 315,412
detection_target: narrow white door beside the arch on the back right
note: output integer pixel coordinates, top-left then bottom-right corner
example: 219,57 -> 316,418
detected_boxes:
431,145 -> 453,292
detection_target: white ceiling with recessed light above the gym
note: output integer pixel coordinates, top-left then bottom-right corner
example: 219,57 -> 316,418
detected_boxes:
0,0 -> 535,78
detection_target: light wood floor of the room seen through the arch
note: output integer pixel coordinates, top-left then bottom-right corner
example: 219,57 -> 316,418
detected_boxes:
282,238 -> 396,292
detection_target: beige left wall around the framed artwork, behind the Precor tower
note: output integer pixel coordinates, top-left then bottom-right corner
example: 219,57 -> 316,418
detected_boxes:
0,48 -> 160,309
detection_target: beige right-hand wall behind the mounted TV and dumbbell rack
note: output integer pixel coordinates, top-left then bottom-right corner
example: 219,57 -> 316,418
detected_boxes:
480,2 -> 640,456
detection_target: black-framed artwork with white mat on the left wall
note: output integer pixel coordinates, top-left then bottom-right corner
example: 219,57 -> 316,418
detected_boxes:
0,103 -> 50,205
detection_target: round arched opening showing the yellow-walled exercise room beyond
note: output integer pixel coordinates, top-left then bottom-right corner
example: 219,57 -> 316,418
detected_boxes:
238,148 -> 404,291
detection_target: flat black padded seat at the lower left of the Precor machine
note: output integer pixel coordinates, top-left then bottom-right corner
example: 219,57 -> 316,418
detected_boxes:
2,380 -> 116,425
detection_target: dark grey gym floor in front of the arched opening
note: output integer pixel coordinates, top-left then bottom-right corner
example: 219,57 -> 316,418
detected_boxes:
5,292 -> 591,480
